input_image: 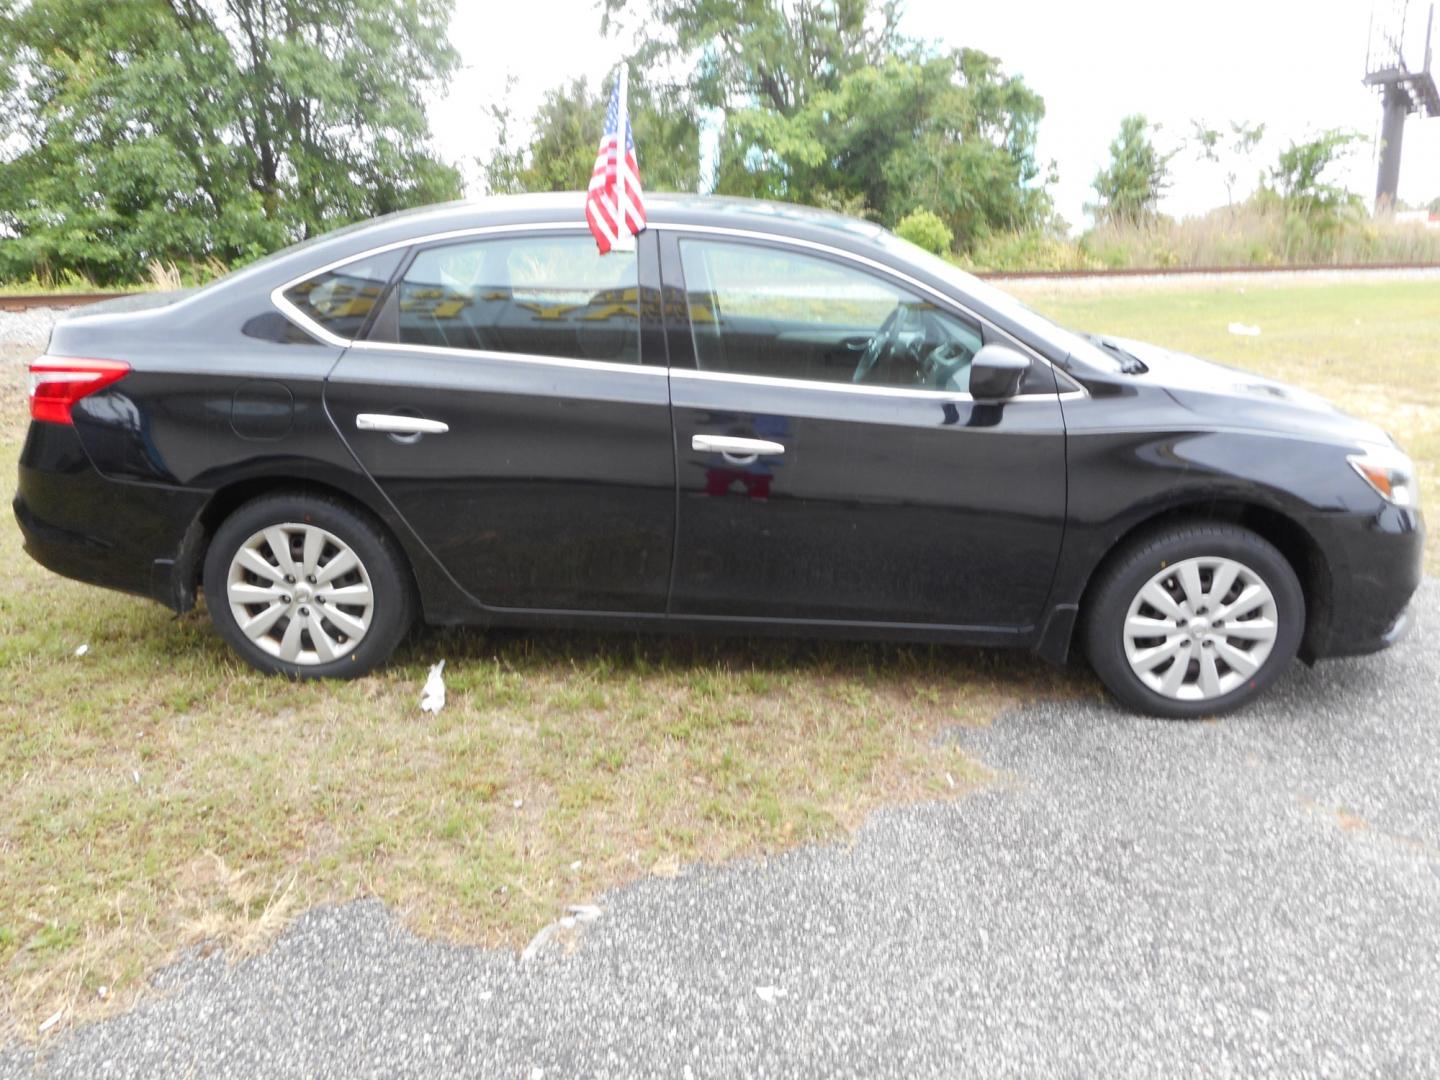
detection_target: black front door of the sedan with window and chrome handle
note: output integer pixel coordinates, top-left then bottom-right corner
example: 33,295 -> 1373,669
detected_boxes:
665,233 -> 1066,631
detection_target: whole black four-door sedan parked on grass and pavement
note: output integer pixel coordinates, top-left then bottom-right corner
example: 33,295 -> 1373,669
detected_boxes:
14,194 -> 1424,716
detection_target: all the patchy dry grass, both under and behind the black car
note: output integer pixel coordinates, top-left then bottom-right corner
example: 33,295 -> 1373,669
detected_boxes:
0,276 -> 1440,1041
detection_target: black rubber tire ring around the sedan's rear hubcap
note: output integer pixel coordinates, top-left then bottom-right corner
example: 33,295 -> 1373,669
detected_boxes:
203,494 -> 416,678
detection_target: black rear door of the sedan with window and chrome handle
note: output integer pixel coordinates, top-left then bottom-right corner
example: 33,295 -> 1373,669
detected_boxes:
316,228 -> 675,615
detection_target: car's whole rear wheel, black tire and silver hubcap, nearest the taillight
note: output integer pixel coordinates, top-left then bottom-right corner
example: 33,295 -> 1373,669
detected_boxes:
204,495 -> 415,678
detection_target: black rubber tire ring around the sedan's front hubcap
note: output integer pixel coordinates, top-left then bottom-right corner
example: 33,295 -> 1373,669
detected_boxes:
1083,523 -> 1305,719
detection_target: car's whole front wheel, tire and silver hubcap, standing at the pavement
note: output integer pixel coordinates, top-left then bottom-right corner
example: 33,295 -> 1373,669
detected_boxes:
1084,524 -> 1305,717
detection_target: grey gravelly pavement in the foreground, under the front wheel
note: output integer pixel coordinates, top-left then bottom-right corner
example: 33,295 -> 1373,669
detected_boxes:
11,580 -> 1440,1080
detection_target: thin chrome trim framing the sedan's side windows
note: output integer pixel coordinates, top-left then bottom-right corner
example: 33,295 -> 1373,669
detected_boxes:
271,222 -> 1090,403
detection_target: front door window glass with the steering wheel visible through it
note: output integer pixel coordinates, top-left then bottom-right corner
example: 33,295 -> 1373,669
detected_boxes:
680,239 -> 982,392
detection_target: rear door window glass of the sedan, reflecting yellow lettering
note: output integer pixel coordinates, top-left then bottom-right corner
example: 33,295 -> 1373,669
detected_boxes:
377,233 -> 639,363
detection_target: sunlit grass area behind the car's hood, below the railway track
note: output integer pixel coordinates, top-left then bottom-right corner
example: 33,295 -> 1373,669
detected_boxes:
1012,279 -> 1440,575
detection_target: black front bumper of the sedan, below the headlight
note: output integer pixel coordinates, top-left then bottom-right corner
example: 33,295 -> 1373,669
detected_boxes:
1305,504 -> 1426,660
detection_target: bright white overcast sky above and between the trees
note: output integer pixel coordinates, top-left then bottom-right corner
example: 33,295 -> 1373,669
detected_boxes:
431,0 -> 1440,225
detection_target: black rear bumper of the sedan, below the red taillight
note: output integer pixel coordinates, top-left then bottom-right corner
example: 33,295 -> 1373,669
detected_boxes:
13,423 -> 206,611
